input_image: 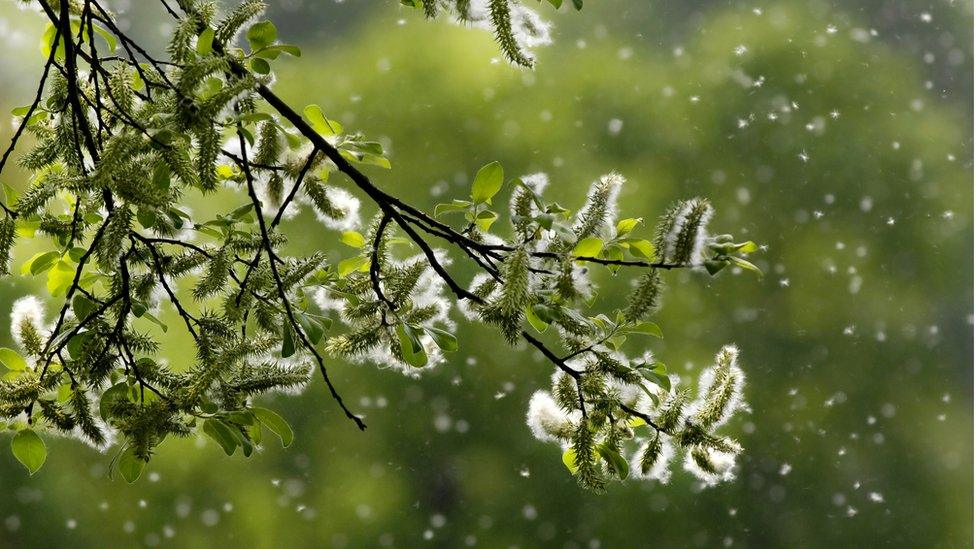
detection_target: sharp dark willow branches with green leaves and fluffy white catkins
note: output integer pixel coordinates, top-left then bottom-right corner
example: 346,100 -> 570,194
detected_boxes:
0,0 -> 755,490
